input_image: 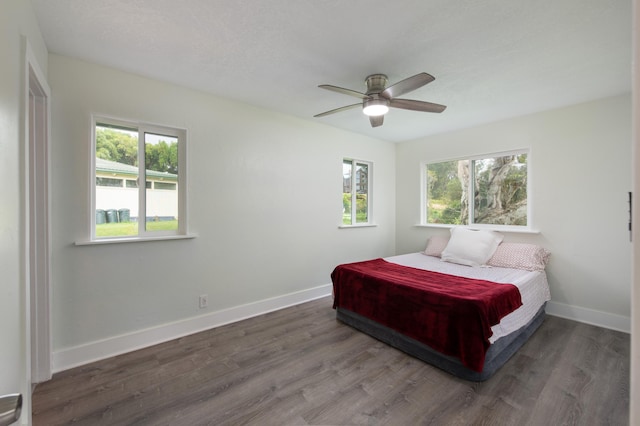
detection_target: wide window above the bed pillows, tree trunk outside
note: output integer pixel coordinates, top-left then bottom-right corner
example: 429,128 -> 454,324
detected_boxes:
422,151 -> 529,227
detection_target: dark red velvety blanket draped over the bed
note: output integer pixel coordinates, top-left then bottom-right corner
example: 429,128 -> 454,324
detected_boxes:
331,259 -> 522,372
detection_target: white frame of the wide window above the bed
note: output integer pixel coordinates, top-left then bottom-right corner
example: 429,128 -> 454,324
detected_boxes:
419,148 -> 538,233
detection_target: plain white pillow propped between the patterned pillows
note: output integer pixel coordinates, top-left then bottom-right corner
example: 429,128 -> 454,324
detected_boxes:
441,227 -> 503,266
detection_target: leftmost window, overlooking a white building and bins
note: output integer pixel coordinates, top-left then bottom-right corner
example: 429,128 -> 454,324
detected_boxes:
92,117 -> 186,240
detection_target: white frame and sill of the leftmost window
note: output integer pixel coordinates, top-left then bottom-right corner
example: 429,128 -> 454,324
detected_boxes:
85,114 -> 190,245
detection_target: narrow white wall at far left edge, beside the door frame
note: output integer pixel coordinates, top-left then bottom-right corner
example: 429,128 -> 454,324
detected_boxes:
0,0 -> 47,421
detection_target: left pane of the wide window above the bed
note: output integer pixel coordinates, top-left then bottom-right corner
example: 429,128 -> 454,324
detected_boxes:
427,160 -> 469,225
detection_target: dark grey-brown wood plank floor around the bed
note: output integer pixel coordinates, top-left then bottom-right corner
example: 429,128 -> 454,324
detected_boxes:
33,298 -> 630,426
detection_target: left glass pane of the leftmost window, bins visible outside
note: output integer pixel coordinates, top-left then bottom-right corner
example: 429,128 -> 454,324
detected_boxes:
95,124 -> 138,238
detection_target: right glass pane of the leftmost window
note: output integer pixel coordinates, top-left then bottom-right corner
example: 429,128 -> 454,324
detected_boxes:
144,133 -> 178,231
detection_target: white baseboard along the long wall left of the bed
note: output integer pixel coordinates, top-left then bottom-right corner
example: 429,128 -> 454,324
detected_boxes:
53,284 -> 332,373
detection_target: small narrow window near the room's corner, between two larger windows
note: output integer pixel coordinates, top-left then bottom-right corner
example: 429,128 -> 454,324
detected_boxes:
342,159 -> 372,225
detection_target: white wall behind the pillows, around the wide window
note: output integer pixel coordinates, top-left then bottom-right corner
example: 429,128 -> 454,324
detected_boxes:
396,95 -> 631,331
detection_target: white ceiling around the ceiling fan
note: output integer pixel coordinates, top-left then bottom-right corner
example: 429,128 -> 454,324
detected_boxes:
32,0 -> 632,142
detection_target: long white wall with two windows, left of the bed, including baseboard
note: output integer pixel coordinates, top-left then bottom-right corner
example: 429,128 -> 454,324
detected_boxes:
49,55 -> 395,369
